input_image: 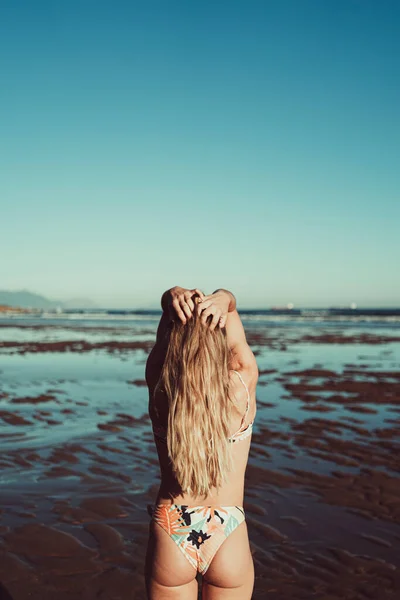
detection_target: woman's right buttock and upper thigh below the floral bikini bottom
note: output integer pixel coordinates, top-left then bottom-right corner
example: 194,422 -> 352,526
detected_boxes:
202,521 -> 254,600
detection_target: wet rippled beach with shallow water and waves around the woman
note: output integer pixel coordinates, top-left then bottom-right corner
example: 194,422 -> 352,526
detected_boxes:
0,315 -> 400,600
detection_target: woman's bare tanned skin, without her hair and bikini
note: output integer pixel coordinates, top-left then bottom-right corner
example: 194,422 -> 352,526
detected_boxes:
146,288 -> 258,600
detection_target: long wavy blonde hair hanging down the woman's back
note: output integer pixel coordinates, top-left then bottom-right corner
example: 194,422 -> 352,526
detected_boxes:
156,311 -> 233,497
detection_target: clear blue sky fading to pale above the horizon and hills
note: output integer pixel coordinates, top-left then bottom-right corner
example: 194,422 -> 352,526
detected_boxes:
0,0 -> 400,307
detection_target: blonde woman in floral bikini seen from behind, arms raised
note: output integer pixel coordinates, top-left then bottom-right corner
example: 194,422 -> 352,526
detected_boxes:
146,287 -> 258,600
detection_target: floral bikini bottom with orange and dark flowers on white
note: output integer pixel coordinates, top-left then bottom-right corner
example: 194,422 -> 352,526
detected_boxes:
152,504 -> 245,575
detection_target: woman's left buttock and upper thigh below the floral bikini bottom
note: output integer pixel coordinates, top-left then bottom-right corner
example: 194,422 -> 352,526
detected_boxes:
145,521 -> 198,600
